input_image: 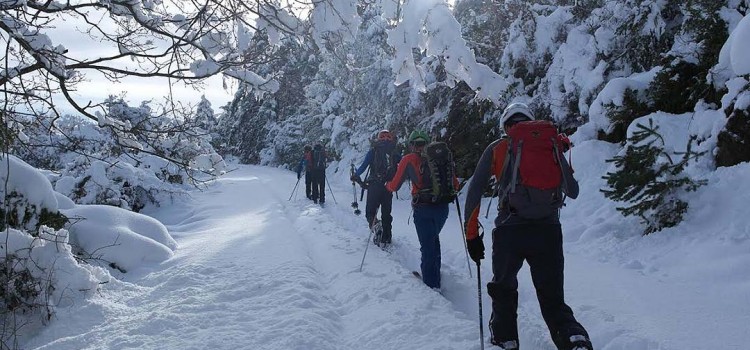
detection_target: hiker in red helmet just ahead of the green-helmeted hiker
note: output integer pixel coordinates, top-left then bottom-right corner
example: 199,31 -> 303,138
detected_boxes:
351,130 -> 401,248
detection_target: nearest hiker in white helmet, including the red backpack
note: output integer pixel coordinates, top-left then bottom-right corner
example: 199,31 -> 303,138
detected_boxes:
464,103 -> 593,350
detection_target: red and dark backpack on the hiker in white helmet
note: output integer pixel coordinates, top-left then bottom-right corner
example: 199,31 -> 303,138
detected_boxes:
498,120 -> 578,219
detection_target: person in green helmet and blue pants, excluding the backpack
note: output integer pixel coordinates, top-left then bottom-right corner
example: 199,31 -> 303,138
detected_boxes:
385,130 -> 458,290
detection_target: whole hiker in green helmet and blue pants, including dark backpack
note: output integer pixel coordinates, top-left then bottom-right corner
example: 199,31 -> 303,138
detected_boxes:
385,131 -> 458,290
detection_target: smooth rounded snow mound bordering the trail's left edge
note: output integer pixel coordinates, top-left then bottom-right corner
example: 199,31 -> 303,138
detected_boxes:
61,205 -> 177,271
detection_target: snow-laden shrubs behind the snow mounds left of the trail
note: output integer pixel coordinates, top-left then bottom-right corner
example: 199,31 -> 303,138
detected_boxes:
11,97 -> 225,211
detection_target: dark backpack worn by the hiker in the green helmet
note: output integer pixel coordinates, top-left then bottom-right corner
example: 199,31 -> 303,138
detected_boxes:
418,142 -> 457,204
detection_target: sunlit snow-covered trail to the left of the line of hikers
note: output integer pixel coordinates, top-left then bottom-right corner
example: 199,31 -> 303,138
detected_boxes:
27,167 -> 479,350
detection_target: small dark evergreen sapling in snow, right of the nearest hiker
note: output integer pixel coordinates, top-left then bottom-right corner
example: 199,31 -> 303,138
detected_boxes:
601,119 -> 706,235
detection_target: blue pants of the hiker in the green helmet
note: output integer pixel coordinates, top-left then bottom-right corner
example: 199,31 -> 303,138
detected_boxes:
414,204 -> 448,288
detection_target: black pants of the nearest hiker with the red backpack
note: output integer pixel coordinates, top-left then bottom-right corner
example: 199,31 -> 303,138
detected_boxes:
487,223 -> 588,349
